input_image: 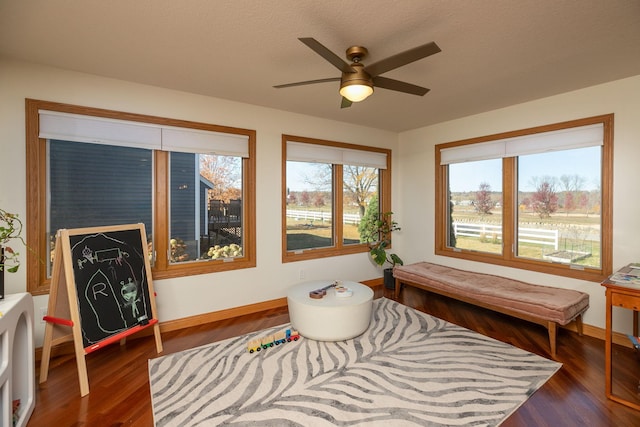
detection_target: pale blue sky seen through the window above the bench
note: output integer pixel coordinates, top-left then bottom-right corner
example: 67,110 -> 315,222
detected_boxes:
449,146 -> 601,193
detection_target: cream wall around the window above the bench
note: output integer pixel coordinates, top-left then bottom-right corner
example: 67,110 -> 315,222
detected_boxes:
393,76 -> 640,333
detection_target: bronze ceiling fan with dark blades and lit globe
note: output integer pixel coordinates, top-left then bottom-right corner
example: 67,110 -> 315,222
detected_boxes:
274,37 -> 441,108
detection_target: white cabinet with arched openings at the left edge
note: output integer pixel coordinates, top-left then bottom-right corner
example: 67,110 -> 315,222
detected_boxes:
0,293 -> 36,427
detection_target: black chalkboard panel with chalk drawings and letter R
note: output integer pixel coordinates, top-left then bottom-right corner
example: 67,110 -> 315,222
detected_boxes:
69,225 -> 153,348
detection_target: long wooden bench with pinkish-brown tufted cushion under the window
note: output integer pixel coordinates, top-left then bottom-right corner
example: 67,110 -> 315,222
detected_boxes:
393,262 -> 589,359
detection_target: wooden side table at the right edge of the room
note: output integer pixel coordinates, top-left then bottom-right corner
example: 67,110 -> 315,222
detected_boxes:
602,266 -> 640,410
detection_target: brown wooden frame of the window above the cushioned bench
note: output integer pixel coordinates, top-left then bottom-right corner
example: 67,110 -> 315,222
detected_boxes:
435,114 -> 614,282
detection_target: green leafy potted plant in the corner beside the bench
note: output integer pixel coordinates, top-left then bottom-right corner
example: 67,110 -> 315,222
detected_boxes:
361,212 -> 403,289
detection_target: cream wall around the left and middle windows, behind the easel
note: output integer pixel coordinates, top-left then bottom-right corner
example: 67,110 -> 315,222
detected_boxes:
0,60 -> 398,345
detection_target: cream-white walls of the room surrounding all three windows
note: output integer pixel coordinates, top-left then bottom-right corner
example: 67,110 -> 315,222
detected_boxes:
0,59 -> 640,345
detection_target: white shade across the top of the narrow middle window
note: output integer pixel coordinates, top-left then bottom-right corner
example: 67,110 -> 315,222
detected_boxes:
287,141 -> 387,169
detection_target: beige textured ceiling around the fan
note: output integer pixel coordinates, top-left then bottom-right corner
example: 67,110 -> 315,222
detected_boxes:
0,0 -> 640,131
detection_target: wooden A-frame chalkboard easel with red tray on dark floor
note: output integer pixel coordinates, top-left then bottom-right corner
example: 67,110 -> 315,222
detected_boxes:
40,224 -> 162,396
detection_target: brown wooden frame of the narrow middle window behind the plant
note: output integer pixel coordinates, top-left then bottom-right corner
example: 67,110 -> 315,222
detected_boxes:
282,135 -> 391,263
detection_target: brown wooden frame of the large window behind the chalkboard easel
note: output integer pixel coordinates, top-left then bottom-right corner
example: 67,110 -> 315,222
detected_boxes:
25,99 -> 256,295
